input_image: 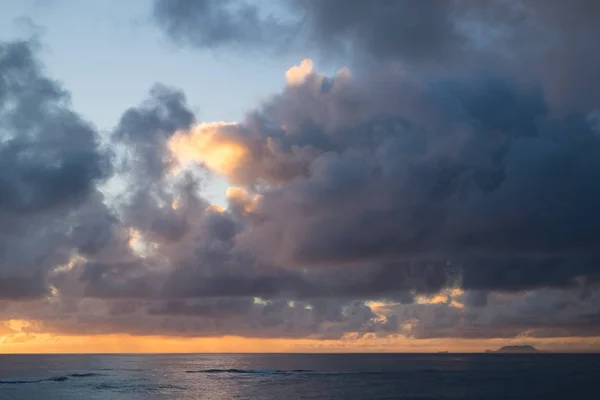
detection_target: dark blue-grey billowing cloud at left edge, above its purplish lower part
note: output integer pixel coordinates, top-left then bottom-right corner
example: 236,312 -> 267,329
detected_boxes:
0,42 -> 110,214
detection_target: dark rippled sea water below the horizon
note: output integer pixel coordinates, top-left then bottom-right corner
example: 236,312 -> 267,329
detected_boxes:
0,354 -> 600,400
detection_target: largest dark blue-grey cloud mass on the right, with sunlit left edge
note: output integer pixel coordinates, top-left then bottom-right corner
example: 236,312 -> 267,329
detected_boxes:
118,55 -> 599,337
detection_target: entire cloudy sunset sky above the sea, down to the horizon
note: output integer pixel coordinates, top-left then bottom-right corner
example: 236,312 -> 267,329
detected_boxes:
0,0 -> 600,353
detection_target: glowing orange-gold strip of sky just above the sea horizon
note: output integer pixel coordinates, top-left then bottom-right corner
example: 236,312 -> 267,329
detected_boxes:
0,321 -> 600,354
